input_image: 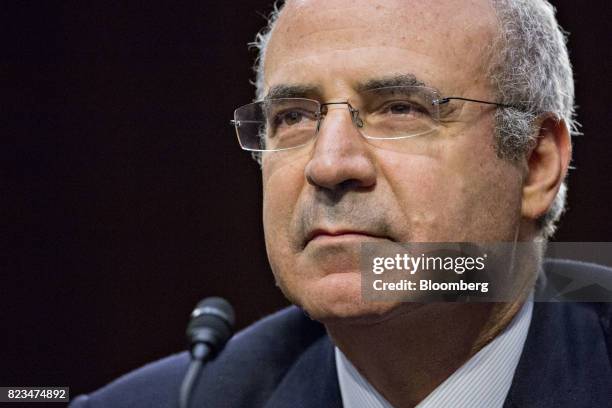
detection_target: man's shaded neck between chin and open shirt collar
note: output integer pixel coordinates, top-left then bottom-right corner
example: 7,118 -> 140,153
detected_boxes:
326,299 -> 524,407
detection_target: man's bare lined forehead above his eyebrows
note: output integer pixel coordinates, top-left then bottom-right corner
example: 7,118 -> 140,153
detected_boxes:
264,0 -> 496,96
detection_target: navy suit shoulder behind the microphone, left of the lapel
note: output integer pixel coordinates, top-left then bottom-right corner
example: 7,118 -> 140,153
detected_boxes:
71,306 -> 325,408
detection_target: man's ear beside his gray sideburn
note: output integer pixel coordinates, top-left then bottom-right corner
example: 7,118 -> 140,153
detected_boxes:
521,114 -> 572,220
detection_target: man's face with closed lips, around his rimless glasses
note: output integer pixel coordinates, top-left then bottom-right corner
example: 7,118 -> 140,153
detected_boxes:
262,0 -> 522,321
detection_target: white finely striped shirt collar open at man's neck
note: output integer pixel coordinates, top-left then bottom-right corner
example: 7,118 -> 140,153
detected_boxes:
336,298 -> 533,408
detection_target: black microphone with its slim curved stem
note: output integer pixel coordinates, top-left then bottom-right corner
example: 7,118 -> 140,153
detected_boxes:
179,297 -> 235,408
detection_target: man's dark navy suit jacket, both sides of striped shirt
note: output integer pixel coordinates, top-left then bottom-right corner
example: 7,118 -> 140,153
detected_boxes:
71,262 -> 612,408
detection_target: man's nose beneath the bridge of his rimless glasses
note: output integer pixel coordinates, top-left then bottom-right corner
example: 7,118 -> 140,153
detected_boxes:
305,106 -> 376,192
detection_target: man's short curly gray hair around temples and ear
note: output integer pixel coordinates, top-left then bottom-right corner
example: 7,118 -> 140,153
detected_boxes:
249,0 -> 578,239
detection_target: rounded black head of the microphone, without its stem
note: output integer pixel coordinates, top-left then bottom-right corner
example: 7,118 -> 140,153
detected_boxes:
187,297 -> 235,354
